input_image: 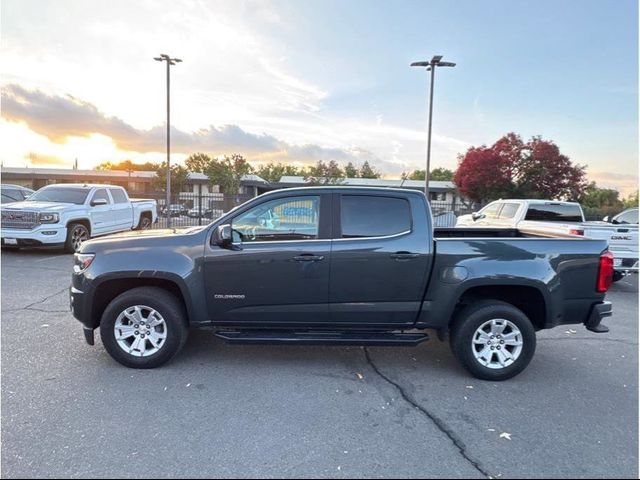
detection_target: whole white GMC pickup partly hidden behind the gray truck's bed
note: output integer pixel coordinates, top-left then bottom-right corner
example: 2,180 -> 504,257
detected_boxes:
456,199 -> 638,281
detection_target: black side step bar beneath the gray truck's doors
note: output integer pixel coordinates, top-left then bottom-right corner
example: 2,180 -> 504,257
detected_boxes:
215,330 -> 429,347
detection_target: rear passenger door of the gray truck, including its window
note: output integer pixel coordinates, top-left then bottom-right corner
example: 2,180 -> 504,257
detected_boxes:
329,192 -> 433,327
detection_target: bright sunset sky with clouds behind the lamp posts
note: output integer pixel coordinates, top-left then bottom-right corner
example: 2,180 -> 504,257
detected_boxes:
0,0 -> 638,194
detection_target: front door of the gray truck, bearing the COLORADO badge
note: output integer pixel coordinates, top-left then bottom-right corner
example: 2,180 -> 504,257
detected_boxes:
204,193 -> 331,327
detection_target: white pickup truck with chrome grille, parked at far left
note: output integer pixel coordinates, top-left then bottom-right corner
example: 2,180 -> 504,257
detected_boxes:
0,184 -> 158,253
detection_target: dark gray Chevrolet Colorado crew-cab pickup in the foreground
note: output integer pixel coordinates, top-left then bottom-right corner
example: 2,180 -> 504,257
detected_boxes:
70,187 -> 613,380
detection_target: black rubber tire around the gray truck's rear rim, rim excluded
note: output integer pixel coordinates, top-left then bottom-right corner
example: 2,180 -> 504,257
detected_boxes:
450,300 -> 536,382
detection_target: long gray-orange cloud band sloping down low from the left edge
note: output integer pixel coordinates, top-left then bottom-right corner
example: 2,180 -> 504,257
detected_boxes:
2,84 -> 402,173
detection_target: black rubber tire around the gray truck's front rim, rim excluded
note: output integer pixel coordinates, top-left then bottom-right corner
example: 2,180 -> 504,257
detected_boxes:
100,287 -> 189,369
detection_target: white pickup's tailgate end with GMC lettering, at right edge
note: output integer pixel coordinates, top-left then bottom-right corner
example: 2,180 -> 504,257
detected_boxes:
584,208 -> 638,282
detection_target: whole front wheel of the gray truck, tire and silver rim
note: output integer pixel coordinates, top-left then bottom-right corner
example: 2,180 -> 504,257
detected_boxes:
100,287 -> 188,368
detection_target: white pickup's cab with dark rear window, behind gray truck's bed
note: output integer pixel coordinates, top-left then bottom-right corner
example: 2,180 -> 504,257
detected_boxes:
456,200 -> 585,236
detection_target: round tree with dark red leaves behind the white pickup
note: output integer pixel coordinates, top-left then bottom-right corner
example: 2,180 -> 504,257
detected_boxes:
454,133 -> 587,202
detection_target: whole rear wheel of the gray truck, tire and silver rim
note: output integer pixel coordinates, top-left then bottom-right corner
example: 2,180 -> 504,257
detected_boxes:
450,300 -> 536,381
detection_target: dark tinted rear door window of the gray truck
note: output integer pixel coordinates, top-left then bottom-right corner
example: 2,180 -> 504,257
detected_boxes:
340,195 -> 411,238
